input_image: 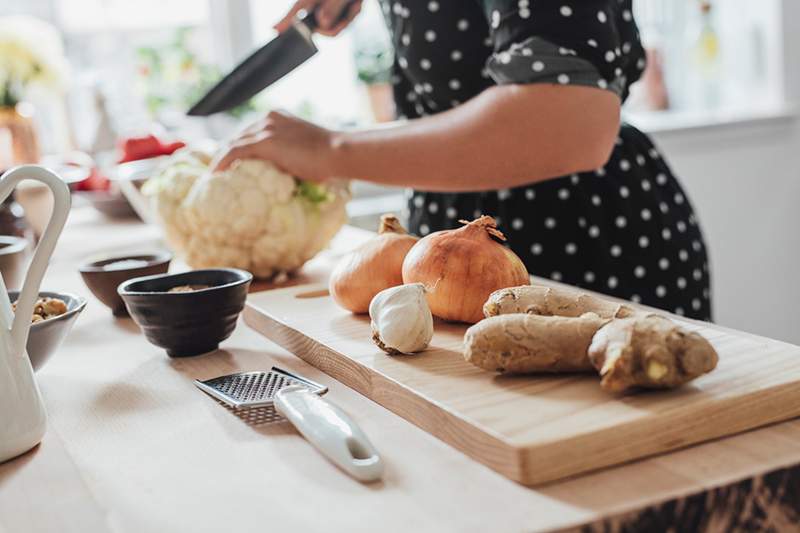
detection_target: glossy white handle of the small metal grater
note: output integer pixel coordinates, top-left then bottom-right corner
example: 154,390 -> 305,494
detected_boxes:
275,385 -> 383,481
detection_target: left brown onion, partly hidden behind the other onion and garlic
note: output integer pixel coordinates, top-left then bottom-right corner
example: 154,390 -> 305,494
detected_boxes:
328,215 -> 417,313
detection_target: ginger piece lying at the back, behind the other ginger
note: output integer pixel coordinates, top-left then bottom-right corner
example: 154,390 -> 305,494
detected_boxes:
483,285 -> 636,318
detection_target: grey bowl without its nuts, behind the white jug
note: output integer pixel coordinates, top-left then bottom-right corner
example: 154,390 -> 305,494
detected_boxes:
8,291 -> 86,370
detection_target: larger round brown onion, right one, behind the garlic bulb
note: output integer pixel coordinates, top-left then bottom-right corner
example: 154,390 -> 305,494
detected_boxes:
403,216 -> 530,324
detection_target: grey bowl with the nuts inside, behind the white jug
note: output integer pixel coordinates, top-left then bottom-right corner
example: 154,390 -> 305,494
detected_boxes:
8,291 -> 86,370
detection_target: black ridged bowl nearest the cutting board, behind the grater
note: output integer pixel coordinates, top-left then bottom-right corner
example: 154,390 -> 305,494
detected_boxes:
118,268 -> 253,357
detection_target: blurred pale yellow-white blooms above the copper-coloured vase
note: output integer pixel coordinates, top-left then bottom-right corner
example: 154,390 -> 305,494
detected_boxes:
0,15 -> 67,94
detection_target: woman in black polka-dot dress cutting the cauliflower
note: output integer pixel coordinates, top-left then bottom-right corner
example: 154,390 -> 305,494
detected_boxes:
220,0 -> 710,319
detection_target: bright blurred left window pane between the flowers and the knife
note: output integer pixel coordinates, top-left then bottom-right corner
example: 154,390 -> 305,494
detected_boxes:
0,0 -> 215,152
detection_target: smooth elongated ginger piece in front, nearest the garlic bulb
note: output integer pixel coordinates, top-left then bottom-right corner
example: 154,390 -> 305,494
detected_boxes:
464,313 -> 608,374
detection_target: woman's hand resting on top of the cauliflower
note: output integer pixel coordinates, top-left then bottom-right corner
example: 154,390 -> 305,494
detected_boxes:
214,111 -> 336,181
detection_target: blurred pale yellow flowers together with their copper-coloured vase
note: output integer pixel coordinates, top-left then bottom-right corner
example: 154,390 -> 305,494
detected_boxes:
0,16 -> 66,169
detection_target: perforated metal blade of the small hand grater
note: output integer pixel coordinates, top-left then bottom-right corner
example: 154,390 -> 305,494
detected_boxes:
194,366 -> 328,409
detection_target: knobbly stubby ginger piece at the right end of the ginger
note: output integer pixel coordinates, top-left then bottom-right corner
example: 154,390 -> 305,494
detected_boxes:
588,314 -> 719,392
